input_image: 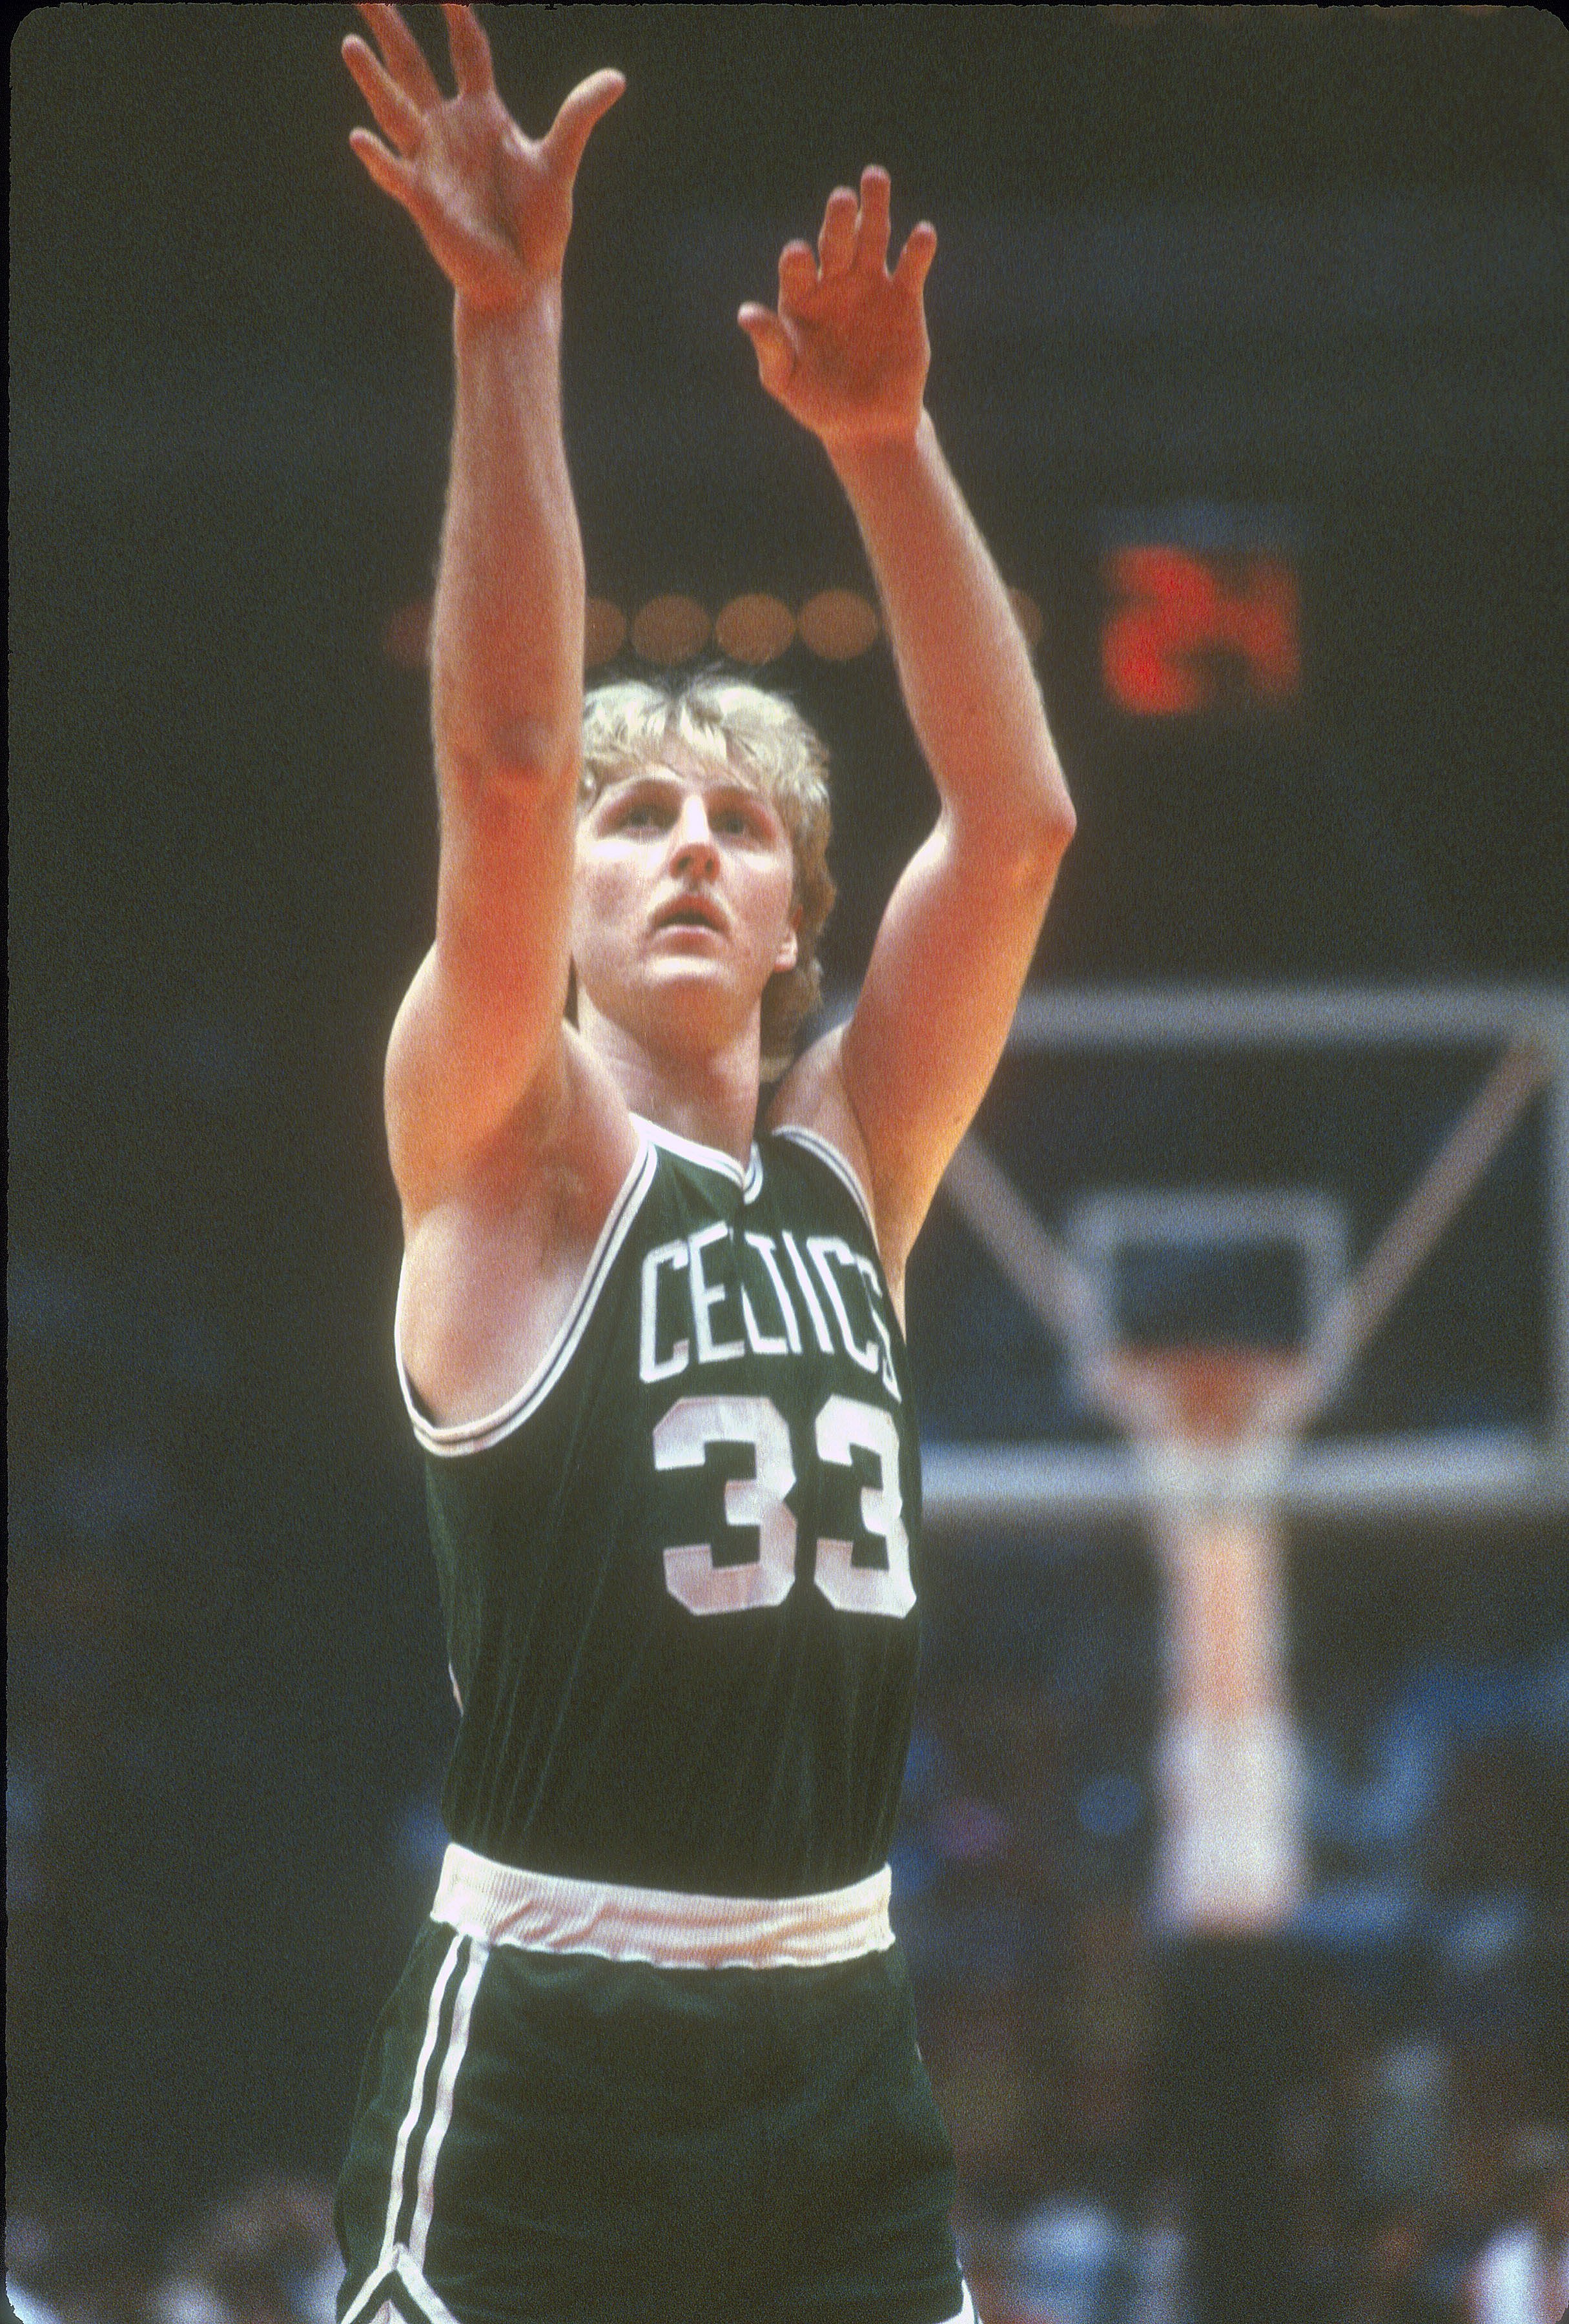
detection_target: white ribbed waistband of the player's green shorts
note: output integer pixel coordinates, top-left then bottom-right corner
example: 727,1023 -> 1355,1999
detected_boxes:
430,1840 -> 892,1968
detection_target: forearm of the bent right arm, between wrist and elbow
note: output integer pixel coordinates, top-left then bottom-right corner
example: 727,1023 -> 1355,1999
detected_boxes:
830,414 -> 1074,860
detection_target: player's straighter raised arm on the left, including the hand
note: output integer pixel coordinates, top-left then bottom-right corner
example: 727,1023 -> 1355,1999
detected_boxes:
344,7 -> 623,1229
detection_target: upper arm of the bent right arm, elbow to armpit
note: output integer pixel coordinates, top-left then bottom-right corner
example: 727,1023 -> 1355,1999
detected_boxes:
839,813 -> 1067,1267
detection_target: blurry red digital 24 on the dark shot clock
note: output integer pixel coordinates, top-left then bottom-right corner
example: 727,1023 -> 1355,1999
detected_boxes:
1100,546 -> 1302,718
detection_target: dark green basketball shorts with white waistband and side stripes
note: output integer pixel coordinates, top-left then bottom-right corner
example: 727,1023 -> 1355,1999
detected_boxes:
337,1850 -> 974,2324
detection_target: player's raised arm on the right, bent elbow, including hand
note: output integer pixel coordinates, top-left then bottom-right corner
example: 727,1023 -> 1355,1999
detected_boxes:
739,170 -> 1074,1281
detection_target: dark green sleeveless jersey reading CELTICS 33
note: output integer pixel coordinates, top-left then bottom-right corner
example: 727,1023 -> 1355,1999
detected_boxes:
404,1123 -> 921,1897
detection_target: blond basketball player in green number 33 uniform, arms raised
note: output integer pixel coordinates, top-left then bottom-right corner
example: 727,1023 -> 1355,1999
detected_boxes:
340,7 -> 1072,2324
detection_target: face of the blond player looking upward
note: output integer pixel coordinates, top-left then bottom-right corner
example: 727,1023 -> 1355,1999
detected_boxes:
572,741 -> 797,1050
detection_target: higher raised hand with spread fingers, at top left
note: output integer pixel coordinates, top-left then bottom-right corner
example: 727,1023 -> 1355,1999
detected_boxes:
344,5 -> 625,309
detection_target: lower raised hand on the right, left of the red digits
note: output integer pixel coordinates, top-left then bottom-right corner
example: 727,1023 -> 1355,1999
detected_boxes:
737,170 -> 937,451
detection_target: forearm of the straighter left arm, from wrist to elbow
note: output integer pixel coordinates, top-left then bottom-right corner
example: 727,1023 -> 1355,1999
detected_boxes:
430,279 -> 584,783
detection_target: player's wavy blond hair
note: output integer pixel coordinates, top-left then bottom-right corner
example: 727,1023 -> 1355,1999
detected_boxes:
581,671 -> 834,1081
